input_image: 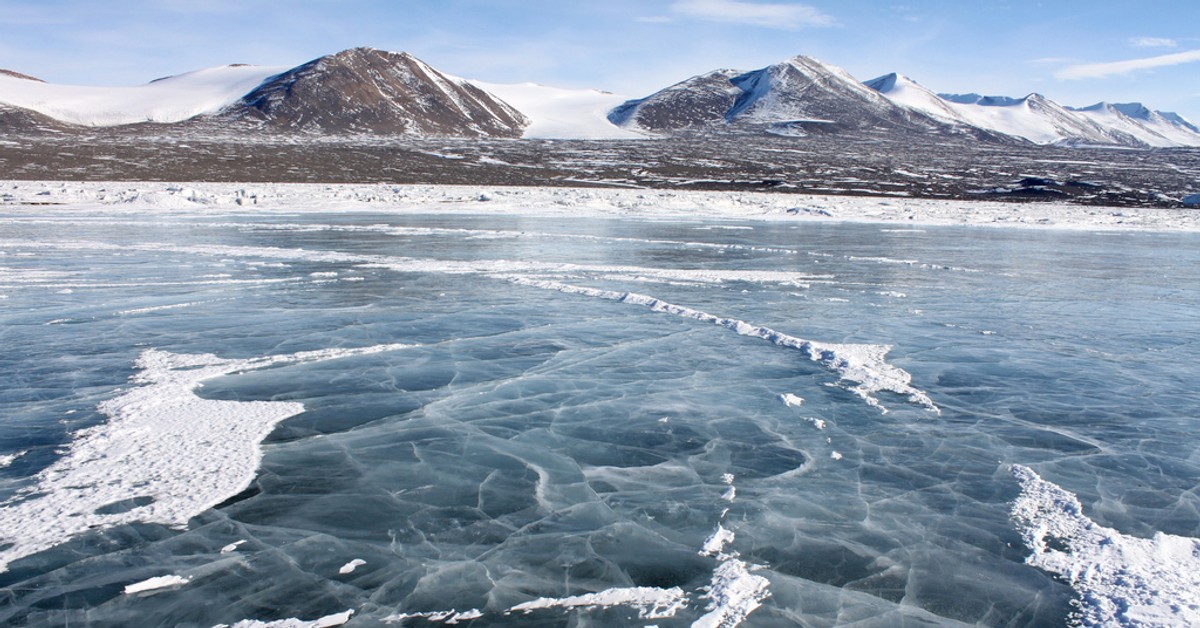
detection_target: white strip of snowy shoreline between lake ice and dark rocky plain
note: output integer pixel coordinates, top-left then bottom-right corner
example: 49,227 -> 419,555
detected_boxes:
0,180 -> 1200,233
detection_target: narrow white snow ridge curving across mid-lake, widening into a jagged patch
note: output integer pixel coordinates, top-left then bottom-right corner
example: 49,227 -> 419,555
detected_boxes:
509,277 -> 941,414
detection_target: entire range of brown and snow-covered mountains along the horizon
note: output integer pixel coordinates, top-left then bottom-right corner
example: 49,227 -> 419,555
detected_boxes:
0,48 -> 1200,149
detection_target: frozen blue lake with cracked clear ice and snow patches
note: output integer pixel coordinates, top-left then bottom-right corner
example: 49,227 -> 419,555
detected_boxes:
0,208 -> 1200,627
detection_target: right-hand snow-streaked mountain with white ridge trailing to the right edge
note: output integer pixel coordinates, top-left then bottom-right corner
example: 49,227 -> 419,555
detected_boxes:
608,56 -> 1200,148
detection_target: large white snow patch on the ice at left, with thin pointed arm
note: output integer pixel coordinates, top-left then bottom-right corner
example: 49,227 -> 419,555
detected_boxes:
0,345 -> 407,570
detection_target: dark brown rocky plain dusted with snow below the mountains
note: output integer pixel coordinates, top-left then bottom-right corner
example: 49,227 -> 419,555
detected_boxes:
0,125 -> 1200,207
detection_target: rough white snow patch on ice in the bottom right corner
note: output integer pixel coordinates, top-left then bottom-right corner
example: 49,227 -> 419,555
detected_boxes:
1012,466 -> 1200,627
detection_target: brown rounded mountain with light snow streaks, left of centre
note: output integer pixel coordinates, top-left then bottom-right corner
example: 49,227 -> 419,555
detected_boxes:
218,48 -> 529,137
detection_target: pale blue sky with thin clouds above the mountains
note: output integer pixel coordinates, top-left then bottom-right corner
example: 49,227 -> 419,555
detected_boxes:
0,0 -> 1200,122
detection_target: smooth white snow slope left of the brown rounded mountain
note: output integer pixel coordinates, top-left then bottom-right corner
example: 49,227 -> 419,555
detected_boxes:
0,65 -> 288,126
